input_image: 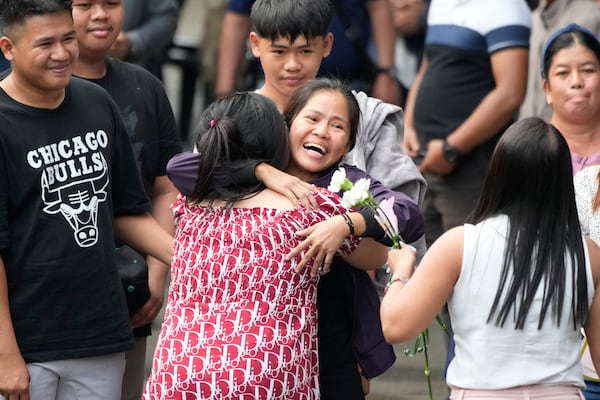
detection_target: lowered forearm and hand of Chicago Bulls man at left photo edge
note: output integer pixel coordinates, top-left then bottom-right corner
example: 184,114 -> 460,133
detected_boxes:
0,256 -> 29,400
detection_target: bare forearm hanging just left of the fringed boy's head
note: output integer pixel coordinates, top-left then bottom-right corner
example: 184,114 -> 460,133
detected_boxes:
215,11 -> 251,97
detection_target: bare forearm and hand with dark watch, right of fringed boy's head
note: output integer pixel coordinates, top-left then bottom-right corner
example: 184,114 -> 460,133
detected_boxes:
367,0 -> 403,105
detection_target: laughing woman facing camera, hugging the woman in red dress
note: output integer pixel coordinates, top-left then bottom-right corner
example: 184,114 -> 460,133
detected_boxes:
168,78 -> 424,400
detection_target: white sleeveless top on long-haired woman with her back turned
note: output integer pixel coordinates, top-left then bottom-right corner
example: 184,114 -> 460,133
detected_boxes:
446,215 -> 594,390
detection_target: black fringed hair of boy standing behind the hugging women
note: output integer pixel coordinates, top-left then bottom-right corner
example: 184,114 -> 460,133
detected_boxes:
250,0 -> 333,42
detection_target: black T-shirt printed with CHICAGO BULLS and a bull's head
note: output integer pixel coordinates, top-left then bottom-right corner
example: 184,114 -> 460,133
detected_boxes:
0,78 -> 149,362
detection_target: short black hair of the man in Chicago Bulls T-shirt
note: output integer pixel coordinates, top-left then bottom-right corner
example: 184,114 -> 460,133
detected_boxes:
0,0 -> 73,35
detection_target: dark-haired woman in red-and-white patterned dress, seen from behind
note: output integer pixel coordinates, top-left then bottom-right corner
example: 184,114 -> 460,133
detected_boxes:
144,93 -> 386,399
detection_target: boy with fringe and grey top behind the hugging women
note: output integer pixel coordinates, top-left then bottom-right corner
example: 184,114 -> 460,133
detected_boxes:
249,0 -> 426,204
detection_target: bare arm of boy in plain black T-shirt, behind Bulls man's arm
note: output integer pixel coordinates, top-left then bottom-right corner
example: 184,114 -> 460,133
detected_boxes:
131,175 -> 177,327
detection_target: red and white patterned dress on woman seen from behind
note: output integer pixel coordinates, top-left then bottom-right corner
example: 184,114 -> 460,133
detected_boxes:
143,190 -> 357,400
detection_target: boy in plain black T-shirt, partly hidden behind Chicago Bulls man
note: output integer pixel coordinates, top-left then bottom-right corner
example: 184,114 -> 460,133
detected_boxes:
73,0 -> 181,400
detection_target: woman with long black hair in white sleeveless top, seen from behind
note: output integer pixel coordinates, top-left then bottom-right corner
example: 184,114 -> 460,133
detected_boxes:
381,118 -> 600,400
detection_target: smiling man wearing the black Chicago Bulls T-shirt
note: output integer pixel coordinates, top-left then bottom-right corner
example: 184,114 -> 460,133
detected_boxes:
0,0 -> 172,400
